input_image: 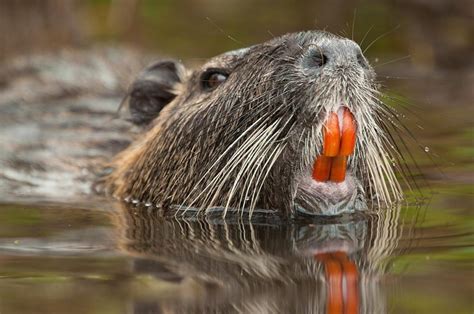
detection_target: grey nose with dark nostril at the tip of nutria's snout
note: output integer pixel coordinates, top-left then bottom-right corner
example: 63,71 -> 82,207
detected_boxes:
303,39 -> 369,70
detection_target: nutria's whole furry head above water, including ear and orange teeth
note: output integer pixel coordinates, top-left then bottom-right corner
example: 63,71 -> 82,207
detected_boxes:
106,31 -> 402,215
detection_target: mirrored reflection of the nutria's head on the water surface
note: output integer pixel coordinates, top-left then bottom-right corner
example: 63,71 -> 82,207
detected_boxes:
115,208 -> 400,313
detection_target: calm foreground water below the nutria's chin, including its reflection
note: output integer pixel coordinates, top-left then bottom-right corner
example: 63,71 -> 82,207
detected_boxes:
0,191 -> 473,313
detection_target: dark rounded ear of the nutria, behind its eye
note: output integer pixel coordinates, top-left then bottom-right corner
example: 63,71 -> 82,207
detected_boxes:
119,60 -> 185,125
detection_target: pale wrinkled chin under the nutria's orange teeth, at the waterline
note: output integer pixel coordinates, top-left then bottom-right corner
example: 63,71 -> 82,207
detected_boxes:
295,173 -> 367,216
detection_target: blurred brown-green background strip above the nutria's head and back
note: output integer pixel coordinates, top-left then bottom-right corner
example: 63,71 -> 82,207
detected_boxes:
0,0 -> 474,70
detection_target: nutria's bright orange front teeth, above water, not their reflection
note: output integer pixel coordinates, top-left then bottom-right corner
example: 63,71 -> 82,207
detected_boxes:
312,107 -> 357,183
